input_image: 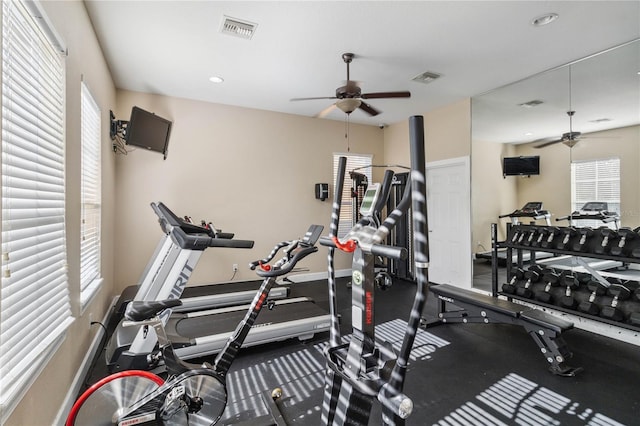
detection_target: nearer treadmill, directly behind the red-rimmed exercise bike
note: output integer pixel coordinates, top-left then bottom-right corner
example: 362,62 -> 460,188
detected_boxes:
106,220 -> 330,372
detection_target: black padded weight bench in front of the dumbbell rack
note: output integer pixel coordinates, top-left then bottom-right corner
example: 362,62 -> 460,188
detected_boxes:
426,284 -> 582,376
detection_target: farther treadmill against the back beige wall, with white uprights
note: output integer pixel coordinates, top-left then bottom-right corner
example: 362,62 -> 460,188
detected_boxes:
112,202 -> 289,324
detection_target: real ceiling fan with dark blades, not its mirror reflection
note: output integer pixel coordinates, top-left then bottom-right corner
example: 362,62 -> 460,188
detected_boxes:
291,53 -> 411,118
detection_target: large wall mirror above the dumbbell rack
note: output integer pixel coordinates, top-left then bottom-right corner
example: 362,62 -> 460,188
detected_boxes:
471,40 -> 640,284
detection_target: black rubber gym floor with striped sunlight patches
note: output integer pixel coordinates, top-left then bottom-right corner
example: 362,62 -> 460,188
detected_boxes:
82,271 -> 640,426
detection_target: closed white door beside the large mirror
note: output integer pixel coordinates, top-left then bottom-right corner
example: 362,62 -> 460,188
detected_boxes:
427,157 -> 472,288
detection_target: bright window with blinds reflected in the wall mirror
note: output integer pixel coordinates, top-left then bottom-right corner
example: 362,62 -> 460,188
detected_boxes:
571,158 -> 620,227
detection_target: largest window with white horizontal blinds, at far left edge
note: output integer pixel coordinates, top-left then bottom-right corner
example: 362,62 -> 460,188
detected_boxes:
0,1 -> 72,423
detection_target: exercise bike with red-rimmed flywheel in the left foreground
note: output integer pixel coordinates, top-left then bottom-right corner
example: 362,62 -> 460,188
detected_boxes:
66,225 -> 323,426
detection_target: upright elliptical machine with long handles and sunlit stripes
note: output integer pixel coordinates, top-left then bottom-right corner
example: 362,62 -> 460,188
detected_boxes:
320,116 -> 429,425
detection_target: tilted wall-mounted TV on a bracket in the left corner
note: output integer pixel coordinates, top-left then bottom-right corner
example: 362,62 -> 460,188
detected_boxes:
125,106 -> 171,159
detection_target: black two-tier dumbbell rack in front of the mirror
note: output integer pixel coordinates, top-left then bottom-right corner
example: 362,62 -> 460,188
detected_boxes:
491,224 -> 640,331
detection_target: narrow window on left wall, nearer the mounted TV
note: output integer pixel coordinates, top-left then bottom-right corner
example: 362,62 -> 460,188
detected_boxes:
80,83 -> 102,307
